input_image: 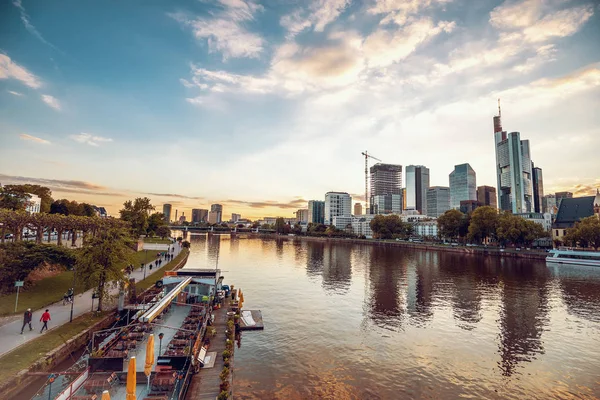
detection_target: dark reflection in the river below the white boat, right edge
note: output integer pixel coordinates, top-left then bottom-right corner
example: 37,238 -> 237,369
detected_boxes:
551,265 -> 600,322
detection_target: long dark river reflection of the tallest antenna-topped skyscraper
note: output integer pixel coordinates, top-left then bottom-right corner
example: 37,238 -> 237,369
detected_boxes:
498,265 -> 549,376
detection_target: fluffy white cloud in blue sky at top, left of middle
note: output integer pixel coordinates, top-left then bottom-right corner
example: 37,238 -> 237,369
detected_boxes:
169,0 -> 264,60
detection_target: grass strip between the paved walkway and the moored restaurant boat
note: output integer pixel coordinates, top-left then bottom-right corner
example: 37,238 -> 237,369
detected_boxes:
0,313 -> 106,383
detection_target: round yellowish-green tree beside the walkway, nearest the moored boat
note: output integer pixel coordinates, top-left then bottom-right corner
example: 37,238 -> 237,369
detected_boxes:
76,228 -> 133,311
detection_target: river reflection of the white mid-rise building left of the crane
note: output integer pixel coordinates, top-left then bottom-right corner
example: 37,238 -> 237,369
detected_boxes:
322,244 -> 352,291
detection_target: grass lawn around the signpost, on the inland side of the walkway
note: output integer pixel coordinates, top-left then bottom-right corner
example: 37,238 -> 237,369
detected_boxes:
0,271 -> 78,316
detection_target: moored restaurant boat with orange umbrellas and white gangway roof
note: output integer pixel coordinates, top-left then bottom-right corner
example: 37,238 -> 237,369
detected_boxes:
34,268 -> 223,400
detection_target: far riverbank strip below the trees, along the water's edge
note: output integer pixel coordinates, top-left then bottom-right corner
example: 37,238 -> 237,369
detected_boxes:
248,234 -> 547,260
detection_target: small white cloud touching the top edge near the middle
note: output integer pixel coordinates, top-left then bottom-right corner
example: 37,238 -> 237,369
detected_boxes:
279,0 -> 350,38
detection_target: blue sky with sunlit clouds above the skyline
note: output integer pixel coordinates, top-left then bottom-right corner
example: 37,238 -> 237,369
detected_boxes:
0,0 -> 600,219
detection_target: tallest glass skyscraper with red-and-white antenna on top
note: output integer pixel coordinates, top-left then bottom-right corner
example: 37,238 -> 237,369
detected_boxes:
494,106 -> 533,214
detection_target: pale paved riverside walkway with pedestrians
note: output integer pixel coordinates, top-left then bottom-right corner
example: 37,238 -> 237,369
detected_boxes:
0,243 -> 182,356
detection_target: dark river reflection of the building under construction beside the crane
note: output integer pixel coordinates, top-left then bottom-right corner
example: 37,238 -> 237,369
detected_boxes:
365,248 -> 407,328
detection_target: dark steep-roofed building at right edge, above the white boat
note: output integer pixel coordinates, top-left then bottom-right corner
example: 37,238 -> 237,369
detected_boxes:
552,190 -> 600,241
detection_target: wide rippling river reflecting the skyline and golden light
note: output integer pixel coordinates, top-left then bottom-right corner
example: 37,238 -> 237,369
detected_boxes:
187,234 -> 600,399
